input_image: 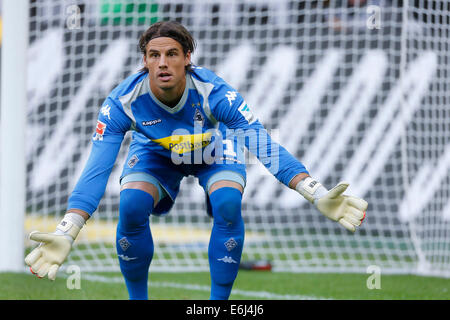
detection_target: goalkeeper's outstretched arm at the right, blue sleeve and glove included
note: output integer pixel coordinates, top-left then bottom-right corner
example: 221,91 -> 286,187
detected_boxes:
209,87 -> 368,232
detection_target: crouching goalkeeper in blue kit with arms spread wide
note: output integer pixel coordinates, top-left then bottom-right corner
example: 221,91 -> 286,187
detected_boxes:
25,21 -> 367,300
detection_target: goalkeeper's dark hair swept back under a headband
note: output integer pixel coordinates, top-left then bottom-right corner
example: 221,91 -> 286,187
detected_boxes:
139,21 -> 196,71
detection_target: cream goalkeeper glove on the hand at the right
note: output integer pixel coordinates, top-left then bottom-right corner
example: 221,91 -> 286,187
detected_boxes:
295,177 -> 368,232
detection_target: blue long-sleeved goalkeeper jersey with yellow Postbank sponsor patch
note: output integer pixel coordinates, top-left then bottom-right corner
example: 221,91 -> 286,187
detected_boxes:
68,67 -> 307,214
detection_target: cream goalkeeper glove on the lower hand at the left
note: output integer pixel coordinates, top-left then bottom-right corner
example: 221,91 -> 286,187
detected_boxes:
25,212 -> 85,280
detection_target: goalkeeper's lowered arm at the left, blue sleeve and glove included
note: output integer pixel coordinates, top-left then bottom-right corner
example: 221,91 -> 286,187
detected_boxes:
25,98 -> 126,280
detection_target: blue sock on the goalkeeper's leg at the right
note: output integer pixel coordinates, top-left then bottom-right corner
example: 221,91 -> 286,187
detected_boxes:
208,187 -> 245,300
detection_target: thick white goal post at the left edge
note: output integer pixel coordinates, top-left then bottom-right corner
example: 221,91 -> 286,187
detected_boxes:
0,0 -> 29,271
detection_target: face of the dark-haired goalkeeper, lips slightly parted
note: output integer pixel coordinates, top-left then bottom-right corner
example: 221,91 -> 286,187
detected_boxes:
144,37 -> 191,98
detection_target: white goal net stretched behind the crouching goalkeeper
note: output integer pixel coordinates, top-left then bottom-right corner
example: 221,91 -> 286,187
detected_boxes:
18,0 -> 450,276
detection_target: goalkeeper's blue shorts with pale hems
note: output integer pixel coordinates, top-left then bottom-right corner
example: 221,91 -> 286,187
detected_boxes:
120,140 -> 246,215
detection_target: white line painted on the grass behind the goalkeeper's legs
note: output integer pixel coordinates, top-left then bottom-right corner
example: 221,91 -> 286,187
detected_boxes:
82,274 -> 330,300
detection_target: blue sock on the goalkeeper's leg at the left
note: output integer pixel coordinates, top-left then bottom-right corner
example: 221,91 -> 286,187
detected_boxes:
116,189 -> 154,300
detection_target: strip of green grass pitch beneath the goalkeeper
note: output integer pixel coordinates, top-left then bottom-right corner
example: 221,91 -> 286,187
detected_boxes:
0,270 -> 450,300
